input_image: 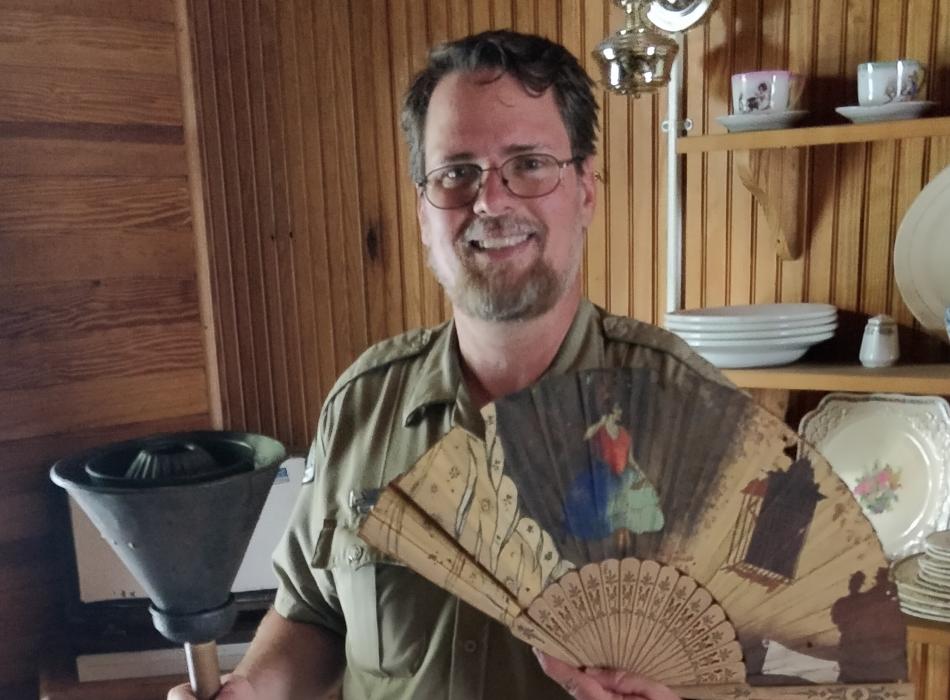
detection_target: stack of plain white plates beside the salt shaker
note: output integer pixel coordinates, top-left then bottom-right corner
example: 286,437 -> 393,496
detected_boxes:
666,304 -> 838,368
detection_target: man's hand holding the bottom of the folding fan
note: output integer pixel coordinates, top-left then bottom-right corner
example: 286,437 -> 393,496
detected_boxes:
534,649 -> 680,700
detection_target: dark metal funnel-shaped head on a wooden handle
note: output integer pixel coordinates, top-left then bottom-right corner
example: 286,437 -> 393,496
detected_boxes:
50,431 -> 285,644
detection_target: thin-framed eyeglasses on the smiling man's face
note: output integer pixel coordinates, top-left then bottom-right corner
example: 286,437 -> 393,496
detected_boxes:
418,153 -> 583,209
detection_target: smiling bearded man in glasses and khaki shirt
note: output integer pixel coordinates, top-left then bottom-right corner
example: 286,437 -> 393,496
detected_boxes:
169,32 -> 718,700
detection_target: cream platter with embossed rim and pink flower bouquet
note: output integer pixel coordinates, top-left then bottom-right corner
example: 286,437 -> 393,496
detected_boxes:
799,394 -> 950,559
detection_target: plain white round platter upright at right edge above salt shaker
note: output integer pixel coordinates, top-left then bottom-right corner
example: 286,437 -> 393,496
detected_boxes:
894,167 -> 950,338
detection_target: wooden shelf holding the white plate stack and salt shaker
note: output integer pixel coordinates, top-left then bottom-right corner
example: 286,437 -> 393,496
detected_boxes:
723,364 -> 950,396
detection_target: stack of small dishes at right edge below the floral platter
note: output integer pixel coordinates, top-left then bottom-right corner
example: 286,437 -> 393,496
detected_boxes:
891,530 -> 950,622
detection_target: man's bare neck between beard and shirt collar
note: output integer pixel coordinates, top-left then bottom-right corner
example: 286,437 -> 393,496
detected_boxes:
455,281 -> 580,408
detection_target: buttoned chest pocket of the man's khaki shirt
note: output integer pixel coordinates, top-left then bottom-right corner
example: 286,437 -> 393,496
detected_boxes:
324,527 -> 434,678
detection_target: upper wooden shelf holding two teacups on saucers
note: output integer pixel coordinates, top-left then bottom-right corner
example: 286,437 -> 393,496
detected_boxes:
676,117 -> 950,153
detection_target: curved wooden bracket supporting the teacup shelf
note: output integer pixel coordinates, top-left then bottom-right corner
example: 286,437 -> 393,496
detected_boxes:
733,148 -> 808,260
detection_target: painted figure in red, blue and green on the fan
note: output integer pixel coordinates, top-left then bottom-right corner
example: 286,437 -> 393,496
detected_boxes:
564,404 -> 663,540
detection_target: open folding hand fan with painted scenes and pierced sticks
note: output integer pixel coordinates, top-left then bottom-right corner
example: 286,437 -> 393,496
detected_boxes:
360,368 -> 913,698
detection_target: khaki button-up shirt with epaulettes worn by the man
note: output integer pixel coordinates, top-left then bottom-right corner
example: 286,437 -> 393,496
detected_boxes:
274,300 -> 725,700
